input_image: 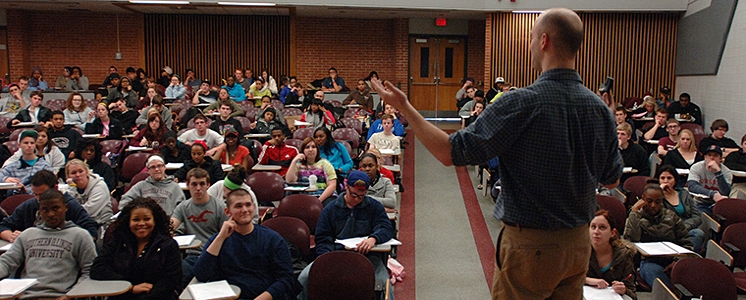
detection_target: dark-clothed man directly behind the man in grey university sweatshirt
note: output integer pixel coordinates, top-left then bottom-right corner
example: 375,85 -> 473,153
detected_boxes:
0,170 -> 98,243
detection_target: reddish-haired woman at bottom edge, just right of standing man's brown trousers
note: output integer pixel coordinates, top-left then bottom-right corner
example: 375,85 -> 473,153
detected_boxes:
585,209 -> 637,299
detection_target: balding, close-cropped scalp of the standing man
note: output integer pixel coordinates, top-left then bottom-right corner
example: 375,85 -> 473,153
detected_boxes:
533,8 -> 583,59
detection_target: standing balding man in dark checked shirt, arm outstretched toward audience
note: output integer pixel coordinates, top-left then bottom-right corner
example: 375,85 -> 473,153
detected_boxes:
373,9 -> 622,299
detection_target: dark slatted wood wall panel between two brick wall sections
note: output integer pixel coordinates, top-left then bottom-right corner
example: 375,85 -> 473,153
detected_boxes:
145,14 -> 290,85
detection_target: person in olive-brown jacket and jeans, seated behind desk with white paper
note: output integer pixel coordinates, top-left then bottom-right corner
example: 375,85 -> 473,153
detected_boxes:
620,179 -> 692,286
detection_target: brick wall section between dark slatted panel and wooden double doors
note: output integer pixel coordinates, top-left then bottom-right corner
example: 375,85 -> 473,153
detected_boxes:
295,18 -> 407,88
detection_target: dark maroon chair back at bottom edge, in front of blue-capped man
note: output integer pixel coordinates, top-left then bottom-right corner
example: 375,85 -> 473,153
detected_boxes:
308,251 -> 376,300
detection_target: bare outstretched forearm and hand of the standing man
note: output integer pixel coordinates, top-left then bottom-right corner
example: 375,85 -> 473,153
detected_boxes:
371,78 -> 453,166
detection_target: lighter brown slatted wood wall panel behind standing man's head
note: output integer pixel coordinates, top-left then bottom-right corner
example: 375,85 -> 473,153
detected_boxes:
487,13 -> 679,100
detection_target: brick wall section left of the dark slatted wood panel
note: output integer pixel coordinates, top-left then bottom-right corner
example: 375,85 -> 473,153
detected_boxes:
8,10 -> 144,85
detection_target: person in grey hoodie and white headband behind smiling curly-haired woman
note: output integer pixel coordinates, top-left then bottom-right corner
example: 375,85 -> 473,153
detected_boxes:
119,155 -> 184,216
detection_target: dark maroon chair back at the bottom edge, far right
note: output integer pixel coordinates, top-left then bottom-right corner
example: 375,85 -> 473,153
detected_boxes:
671,257 -> 738,300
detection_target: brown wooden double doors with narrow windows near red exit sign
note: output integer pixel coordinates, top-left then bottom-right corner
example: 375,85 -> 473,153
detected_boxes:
409,37 -> 466,117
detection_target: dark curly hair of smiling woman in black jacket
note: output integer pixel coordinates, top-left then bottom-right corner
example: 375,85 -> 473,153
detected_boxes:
112,197 -> 173,240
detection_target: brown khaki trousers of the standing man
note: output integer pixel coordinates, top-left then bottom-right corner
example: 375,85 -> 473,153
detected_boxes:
492,225 -> 591,300
